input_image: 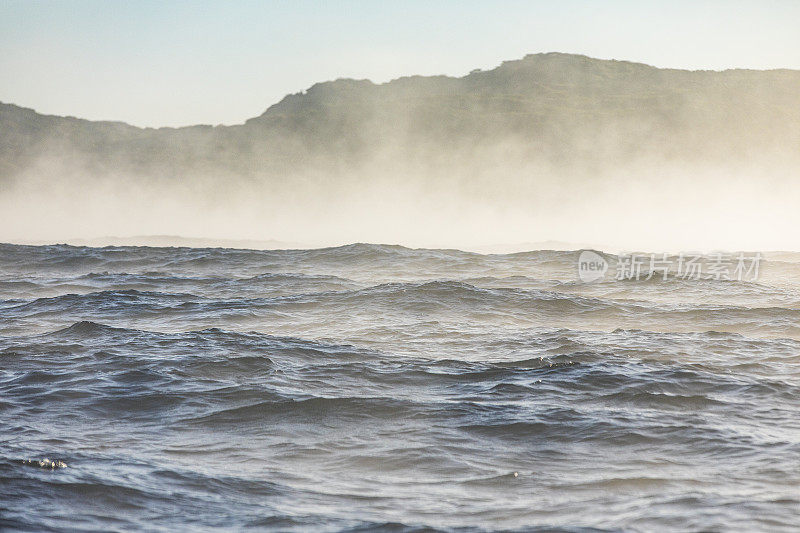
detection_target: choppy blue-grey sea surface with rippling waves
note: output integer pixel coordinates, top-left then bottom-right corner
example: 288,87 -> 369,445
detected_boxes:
0,245 -> 800,531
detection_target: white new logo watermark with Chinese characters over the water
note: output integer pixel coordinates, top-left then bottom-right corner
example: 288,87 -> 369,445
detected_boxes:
578,250 -> 761,283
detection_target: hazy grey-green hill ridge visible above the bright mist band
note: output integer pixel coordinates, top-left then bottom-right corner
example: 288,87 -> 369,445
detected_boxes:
0,53 -> 800,184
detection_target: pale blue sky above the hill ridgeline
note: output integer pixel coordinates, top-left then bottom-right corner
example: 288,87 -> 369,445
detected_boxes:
0,0 -> 800,127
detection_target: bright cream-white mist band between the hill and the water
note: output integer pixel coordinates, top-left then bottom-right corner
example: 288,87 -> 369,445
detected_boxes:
0,150 -> 800,251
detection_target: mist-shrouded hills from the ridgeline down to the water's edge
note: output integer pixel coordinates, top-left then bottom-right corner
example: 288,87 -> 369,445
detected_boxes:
0,54 -> 800,251
